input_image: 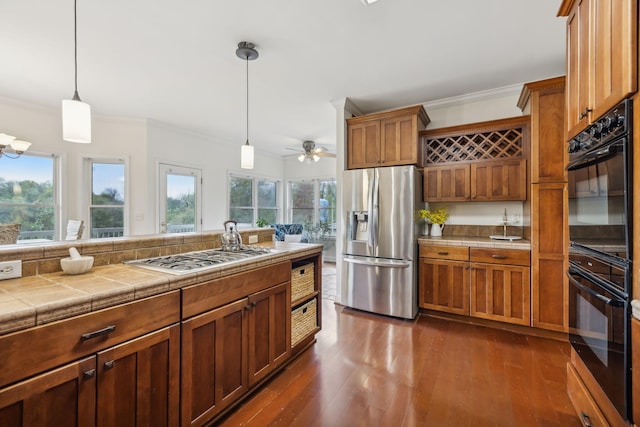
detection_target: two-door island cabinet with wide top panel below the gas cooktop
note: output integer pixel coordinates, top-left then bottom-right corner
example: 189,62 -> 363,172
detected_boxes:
181,262 -> 291,426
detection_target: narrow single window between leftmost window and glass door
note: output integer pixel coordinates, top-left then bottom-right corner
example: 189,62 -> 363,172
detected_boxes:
89,159 -> 125,239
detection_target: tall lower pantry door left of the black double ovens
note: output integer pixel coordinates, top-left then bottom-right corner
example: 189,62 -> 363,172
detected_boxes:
531,183 -> 568,332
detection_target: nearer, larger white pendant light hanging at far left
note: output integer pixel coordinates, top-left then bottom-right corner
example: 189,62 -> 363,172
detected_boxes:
62,0 -> 91,144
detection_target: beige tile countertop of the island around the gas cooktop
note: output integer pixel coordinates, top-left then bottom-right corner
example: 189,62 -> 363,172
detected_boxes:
0,242 -> 322,335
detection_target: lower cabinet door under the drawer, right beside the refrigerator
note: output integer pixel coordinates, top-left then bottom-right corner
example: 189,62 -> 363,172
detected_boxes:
419,258 -> 469,316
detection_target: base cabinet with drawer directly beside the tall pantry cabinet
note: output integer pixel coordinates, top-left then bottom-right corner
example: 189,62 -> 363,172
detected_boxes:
469,248 -> 531,326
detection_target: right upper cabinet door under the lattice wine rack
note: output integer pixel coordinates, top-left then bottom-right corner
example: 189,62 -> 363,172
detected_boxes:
471,159 -> 527,201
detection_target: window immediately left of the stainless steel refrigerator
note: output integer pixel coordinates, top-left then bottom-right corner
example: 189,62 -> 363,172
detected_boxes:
289,179 -> 336,236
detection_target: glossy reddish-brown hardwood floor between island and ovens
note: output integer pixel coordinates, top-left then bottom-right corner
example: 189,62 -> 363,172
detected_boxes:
218,272 -> 581,427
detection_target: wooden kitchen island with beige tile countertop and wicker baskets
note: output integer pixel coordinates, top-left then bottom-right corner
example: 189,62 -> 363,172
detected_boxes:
0,236 -> 322,426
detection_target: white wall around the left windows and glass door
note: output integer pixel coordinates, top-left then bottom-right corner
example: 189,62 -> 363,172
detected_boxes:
0,98 -> 283,239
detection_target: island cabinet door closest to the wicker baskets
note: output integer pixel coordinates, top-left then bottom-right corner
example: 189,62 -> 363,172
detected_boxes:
249,282 -> 291,386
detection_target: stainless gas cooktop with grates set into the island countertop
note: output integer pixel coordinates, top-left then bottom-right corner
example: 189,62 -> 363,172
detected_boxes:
124,246 -> 271,274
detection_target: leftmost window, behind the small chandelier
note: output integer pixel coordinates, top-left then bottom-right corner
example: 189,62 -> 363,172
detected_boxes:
0,154 -> 57,243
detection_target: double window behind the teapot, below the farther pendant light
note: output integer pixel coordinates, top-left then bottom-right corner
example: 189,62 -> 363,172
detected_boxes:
229,175 -> 279,226
